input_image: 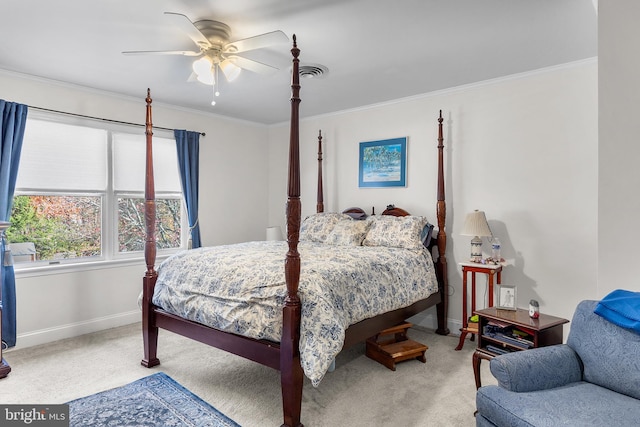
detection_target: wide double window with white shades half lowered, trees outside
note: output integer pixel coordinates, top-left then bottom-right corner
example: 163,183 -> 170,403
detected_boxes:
7,118 -> 188,265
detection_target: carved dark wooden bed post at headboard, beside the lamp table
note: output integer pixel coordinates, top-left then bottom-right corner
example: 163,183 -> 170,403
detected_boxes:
436,110 -> 449,335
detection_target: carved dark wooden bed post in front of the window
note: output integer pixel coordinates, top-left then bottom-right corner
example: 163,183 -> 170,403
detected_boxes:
141,89 -> 160,368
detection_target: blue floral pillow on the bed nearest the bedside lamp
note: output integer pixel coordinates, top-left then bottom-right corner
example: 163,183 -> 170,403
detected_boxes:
362,215 -> 427,249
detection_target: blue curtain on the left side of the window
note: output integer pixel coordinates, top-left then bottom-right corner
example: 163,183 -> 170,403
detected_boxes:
0,99 -> 28,347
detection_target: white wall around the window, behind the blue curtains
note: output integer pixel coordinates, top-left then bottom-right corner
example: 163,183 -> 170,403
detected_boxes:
0,72 -> 268,348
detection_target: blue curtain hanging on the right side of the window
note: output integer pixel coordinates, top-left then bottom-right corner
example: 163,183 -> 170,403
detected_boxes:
173,129 -> 201,248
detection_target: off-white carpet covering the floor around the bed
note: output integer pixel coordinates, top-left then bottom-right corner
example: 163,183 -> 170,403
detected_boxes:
0,324 -> 495,427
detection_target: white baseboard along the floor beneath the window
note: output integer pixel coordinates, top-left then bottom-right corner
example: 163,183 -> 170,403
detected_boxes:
6,310 -> 141,353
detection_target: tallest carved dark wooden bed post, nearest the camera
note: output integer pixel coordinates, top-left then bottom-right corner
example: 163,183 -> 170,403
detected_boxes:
280,34 -> 303,427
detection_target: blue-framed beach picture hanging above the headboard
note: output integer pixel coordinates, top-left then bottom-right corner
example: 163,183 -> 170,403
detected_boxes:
358,137 -> 407,187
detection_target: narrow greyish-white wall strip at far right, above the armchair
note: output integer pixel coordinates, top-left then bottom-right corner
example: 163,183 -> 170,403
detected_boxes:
598,0 -> 640,296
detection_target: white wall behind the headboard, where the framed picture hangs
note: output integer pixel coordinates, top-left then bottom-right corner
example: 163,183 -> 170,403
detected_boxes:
269,59 -> 598,331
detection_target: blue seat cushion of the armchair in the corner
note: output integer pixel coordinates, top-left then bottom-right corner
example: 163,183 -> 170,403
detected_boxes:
476,381 -> 640,427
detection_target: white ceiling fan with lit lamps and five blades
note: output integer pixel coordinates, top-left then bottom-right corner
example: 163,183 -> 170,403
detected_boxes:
122,12 -> 289,105
